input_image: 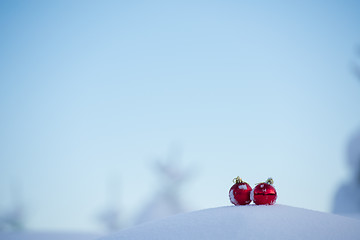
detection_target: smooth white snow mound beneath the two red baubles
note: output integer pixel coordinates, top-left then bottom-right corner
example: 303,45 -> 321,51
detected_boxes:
101,204 -> 360,240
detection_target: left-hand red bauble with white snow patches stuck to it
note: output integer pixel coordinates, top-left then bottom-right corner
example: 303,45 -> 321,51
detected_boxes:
229,177 -> 252,205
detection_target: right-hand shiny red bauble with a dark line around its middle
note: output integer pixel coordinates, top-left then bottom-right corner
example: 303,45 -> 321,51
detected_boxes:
251,178 -> 277,205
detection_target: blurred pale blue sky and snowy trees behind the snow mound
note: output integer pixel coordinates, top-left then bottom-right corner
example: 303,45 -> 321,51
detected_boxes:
0,0 -> 360,232
